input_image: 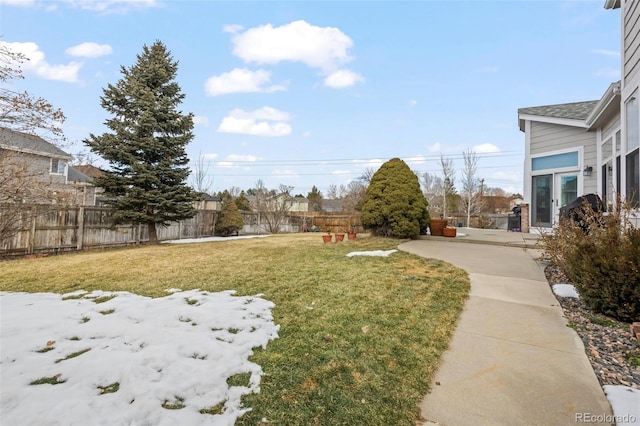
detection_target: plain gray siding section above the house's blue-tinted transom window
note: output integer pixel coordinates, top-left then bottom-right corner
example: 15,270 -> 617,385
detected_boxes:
531,122 -> 596,157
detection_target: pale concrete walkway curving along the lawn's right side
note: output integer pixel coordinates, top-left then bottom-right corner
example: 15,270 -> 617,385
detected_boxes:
399,228 -> 611,426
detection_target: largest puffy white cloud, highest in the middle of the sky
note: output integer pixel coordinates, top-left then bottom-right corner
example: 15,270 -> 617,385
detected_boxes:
232,21 -> 353,72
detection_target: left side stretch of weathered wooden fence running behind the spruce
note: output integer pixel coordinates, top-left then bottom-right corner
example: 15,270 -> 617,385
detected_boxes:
0,205 -> 216,257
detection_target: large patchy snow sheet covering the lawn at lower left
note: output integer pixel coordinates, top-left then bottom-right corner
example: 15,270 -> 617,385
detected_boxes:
0,289 -> 279,425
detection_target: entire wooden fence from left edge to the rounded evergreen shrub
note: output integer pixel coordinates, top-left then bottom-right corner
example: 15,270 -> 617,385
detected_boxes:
0,205 -> 362,257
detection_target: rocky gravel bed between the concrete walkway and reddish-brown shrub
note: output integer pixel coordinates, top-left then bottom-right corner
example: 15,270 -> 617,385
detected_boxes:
544,265 -> 640,389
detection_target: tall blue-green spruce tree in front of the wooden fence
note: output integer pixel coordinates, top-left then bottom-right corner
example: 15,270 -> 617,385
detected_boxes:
83,41 -> 198,244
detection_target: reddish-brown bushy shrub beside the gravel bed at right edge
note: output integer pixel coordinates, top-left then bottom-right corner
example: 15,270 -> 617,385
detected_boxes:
542,204 -> 640,322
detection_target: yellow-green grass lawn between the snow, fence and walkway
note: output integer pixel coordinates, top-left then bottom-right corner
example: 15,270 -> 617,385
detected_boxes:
0,233 -> 470,425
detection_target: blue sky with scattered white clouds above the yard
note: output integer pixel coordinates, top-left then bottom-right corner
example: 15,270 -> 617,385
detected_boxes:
0,0 -> 620,195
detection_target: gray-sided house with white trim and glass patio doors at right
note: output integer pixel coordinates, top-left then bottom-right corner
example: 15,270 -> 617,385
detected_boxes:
518,0 -> 640,228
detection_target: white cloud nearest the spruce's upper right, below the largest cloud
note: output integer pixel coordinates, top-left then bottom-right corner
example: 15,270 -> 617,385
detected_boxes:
204,68 -> 284,96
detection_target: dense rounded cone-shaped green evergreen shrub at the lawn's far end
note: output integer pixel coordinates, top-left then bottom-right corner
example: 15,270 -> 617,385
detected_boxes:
360,158 -> 429,238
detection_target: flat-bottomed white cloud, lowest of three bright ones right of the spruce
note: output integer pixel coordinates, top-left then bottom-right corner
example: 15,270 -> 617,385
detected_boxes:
218,107 -> 292,137
